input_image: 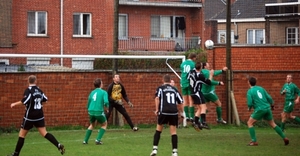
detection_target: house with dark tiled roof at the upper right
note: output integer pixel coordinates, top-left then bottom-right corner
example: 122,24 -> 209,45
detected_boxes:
205,0 -> 300,45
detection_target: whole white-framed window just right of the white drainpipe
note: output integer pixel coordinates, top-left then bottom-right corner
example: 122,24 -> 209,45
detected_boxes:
73,13 -> 92,37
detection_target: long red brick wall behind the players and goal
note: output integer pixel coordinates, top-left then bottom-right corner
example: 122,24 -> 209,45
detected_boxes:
0,47 -> 300,127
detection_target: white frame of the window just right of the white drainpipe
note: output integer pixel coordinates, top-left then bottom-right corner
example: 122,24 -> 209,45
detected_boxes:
73,13 -> 92,37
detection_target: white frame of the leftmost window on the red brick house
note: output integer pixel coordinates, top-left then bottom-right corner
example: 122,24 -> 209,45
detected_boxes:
27,11 -> 47,36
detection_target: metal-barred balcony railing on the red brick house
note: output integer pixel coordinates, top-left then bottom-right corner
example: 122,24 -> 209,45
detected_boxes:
119,36 -> 201,51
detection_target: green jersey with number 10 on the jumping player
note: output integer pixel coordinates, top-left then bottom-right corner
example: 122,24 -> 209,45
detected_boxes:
180,59 -> 195,87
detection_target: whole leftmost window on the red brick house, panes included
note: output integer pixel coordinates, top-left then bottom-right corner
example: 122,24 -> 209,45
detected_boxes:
27,11 -> 47,36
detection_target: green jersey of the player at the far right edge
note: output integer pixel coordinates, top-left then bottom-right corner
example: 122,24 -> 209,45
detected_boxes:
280,82 -> 300,101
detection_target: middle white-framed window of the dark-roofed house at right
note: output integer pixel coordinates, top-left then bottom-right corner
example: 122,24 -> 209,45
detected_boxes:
247,29 -> 265,44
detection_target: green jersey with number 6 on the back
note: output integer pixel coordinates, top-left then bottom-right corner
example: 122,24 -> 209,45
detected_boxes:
247,86 -> 274,111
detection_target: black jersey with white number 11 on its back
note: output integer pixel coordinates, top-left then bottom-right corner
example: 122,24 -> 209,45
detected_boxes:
155,84 -> 183,115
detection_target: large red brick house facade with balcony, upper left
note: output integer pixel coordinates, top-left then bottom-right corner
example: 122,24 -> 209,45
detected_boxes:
0,0 -> 204,65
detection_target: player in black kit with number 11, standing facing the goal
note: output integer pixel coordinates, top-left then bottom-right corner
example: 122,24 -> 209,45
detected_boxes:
150,75 -> 183,156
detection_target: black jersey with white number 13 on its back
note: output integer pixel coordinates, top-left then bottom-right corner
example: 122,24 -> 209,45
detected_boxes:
21,86 -> 48,121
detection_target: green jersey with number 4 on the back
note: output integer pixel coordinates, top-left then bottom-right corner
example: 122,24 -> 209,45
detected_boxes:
87,88 -> 109,116
